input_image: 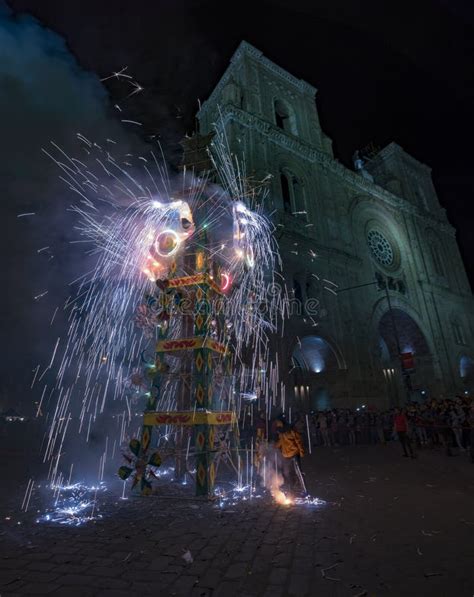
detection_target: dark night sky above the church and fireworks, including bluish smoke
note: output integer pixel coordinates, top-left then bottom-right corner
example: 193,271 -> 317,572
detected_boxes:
0,0 -> 474,406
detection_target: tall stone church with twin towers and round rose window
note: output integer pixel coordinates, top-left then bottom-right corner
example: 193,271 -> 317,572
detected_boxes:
197,42 -> 474,408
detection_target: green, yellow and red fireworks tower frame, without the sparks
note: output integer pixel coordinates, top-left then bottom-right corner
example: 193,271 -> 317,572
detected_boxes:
120,224 -> 238,495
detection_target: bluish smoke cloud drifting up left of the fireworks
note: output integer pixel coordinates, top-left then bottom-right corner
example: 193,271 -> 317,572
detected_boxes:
0,2 -> 141,414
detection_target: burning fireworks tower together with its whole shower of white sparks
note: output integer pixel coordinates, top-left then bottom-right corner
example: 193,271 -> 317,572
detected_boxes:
43,107 -> 287,496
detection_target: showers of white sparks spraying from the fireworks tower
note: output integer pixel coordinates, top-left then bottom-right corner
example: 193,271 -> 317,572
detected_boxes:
35,117 -> 287,508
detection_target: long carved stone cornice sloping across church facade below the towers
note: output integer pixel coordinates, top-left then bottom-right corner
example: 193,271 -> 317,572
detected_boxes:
216,105 -> 455,237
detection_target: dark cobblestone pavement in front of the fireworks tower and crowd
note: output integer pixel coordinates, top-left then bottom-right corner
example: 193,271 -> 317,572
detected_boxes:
0,445 -> 474,597
